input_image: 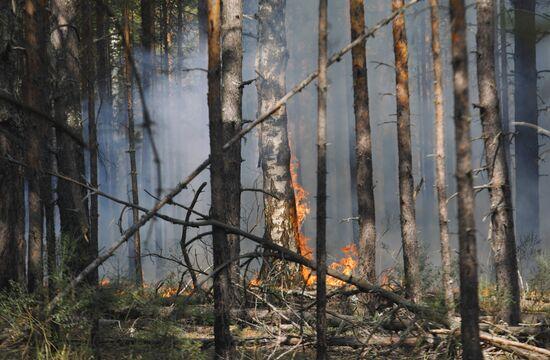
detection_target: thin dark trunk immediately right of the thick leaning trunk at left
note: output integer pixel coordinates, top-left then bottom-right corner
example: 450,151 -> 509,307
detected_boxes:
80,1 -> 99,284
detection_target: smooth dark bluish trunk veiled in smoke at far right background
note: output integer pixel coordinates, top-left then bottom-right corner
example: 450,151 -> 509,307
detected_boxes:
512,0 -> 539,241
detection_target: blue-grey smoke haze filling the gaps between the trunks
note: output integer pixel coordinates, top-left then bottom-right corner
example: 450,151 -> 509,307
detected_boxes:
94,0 -> 550,281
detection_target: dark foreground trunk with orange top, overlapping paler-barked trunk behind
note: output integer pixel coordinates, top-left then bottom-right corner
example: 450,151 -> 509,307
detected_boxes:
208,0 -> 234,359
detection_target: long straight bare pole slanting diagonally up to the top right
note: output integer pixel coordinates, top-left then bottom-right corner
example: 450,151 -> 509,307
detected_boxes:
46,0 -> 419,312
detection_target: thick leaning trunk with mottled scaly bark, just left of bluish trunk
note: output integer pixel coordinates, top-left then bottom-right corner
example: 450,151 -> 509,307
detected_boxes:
476,0 -> 520,325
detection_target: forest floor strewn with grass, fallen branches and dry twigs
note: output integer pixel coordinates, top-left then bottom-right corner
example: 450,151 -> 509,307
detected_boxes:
0,272 -> 550,360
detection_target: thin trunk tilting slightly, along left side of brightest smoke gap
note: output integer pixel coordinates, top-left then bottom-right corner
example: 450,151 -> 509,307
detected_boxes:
122,2 -> 143,286
